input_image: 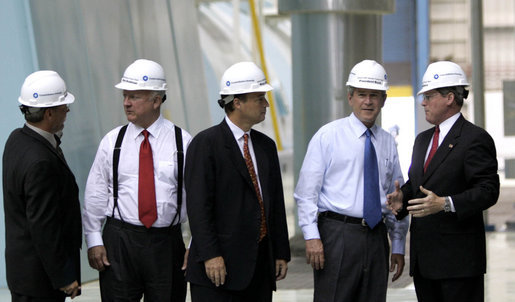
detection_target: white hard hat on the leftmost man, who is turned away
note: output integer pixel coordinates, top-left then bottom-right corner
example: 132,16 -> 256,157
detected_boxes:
18,70 -> 75,108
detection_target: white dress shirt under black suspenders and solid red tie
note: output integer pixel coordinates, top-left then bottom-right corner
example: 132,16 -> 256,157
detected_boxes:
83,116 -> 191,248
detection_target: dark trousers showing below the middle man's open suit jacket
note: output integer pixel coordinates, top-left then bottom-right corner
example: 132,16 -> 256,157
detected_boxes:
190,237 -> 273,302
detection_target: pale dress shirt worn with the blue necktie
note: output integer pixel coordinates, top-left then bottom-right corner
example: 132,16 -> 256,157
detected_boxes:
294,113 -> 409,254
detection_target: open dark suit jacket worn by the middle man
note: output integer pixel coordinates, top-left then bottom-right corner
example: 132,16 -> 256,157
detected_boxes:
185,120 -> 290,290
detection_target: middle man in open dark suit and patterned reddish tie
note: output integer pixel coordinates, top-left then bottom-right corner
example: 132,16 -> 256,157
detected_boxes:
185,62 -> 290,302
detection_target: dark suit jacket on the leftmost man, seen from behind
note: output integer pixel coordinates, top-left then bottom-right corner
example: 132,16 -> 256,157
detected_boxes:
3,126 -> 82,297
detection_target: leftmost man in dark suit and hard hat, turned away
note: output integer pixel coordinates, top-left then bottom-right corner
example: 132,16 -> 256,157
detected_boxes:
3,70 -> 82,302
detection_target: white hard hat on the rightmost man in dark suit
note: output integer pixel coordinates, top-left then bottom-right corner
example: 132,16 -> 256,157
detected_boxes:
417,61 -> 469,95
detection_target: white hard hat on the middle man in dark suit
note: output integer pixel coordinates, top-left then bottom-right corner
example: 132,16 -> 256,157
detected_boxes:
220,62 -> 273,95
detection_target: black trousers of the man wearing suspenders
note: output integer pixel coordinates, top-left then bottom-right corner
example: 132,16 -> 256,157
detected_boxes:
100,218 -> 186,302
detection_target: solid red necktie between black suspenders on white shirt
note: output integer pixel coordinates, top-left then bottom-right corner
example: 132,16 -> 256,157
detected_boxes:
138,130 -> 157,228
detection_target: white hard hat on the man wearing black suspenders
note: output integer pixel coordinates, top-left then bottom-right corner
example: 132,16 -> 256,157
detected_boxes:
114,59 -> 166,91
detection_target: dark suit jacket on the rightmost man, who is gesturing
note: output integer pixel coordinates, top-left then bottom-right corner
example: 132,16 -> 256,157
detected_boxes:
399,116 -> 499,279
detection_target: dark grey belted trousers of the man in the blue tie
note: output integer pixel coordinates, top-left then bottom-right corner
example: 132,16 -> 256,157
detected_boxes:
314,216 -> 390,302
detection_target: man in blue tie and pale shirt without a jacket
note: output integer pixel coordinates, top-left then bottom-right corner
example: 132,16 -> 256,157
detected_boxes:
294,60 -> 409,301
